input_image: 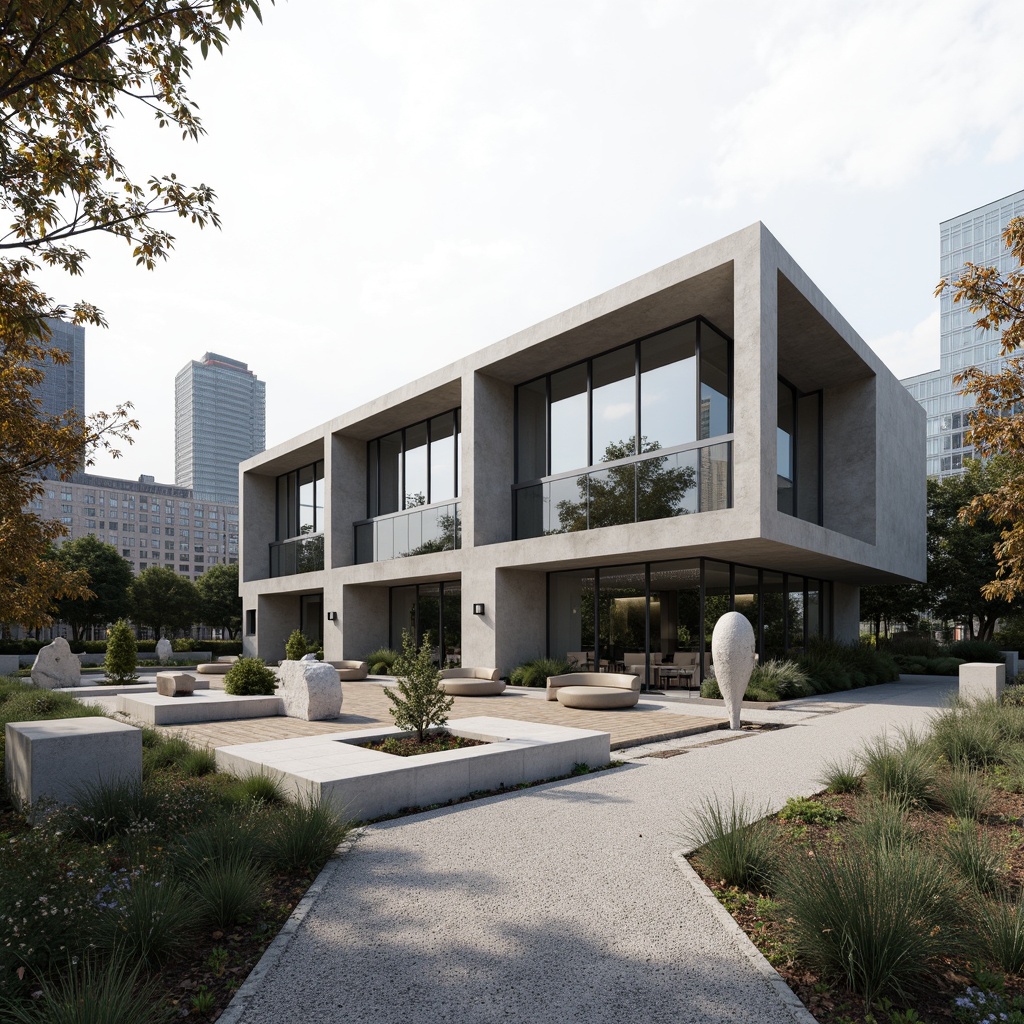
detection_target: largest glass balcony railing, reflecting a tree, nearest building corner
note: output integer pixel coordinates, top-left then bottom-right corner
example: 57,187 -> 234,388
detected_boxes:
513,441 -> 732,540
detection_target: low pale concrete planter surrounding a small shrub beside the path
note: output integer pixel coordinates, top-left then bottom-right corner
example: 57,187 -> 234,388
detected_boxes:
216,717 -> 611,821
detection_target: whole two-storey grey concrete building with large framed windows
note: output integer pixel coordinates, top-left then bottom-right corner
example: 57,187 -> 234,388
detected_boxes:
241,224 -> 926,674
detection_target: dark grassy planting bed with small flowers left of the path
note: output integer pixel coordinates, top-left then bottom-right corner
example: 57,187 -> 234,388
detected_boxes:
0,679 -> 349,1024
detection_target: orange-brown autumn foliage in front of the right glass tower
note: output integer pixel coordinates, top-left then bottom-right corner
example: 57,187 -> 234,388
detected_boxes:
936,217 -> 1024,601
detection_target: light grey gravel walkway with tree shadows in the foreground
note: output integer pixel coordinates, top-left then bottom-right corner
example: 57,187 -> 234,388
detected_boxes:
221,677 -> 954,1024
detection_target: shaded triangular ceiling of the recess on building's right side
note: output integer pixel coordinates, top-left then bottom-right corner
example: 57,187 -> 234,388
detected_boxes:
778,270 -> 874,392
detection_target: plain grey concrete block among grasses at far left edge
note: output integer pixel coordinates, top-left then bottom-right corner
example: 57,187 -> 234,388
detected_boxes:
4,718 -> 142,806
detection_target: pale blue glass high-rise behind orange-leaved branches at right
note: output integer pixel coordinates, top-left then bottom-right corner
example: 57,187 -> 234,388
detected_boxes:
903,191 -> 1024,477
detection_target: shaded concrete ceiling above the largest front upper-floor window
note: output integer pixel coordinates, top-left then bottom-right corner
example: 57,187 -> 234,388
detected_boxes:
477,260 -> 734,384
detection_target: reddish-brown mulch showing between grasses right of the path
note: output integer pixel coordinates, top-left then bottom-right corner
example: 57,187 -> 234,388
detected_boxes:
690,790 -> 1024,1024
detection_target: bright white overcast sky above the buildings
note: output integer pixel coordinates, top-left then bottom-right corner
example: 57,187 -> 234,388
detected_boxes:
66,0 -> 1024,482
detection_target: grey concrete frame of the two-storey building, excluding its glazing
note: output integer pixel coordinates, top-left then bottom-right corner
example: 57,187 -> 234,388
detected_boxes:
240,223 -> 926,675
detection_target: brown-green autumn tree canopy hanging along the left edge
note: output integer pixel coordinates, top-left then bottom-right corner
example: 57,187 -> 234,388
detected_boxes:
0,0 -> 268,626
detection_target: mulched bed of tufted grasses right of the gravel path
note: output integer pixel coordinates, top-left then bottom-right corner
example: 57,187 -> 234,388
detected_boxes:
686,697 -> 1024,1024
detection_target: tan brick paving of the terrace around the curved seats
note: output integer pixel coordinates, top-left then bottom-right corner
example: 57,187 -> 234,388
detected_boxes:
167,682 -> 726,750
